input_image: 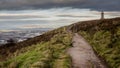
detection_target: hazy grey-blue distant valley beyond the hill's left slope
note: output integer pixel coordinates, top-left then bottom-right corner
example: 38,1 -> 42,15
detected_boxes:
0,28 -> 52,45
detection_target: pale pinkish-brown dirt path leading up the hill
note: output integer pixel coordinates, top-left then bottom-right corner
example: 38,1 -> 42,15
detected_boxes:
68,33 -> 107,68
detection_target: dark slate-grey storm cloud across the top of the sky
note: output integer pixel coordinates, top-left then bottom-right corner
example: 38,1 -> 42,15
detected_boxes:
0,0 -> 120,11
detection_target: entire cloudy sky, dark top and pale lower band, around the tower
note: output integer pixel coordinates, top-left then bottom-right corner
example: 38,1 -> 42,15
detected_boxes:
0,0 -> 120,32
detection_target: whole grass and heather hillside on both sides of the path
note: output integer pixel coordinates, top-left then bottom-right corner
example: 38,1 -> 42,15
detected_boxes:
0,18 -> 120,68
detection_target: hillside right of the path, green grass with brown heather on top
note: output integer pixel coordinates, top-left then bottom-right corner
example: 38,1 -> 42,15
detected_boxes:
70,18 -> 120,68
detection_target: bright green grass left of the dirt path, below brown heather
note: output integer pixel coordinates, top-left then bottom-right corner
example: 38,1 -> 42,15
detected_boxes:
0,29 -> 72,68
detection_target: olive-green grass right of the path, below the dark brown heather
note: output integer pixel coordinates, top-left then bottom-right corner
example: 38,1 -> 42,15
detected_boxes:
78,27 -> 120,68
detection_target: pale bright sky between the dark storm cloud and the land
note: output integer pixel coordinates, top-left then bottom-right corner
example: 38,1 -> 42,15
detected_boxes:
0,7 -> 120,31
